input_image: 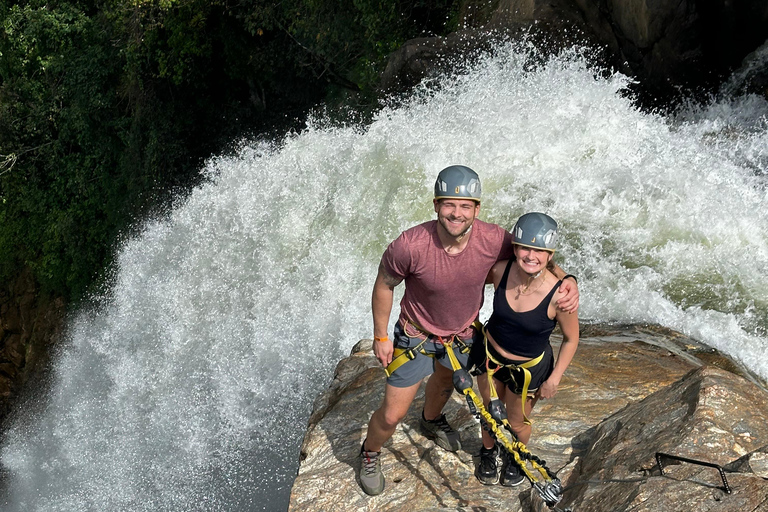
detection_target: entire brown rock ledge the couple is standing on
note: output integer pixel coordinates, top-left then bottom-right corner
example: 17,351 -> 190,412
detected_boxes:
289,327 -> 768,512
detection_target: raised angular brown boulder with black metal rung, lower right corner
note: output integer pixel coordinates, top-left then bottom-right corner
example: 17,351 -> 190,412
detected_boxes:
565,367 -> 768,511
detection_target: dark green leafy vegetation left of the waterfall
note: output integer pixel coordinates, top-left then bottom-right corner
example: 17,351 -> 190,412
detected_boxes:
0,0 -> 457,300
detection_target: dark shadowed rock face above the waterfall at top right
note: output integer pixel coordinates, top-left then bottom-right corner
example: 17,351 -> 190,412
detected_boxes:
381,0 -> 768,104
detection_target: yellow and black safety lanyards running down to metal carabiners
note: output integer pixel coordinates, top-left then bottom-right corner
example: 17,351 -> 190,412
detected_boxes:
438,343 -> 569,512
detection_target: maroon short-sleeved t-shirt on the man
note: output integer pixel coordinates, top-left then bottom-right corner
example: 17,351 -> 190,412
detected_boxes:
382,219 -> 513,336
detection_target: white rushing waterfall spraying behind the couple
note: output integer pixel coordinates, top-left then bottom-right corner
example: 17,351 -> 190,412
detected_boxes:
1,41 -> 768,512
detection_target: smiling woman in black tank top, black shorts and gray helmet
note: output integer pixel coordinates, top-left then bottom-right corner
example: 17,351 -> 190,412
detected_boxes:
472,212 -> 579,486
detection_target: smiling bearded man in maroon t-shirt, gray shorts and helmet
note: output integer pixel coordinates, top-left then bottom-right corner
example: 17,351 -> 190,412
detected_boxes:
360,165 -> 578,496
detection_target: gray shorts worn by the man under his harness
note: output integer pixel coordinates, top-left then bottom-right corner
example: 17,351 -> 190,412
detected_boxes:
387,322 -> 483,388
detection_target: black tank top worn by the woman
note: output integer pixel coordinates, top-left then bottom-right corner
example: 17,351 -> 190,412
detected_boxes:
486,260 -> 562,358
